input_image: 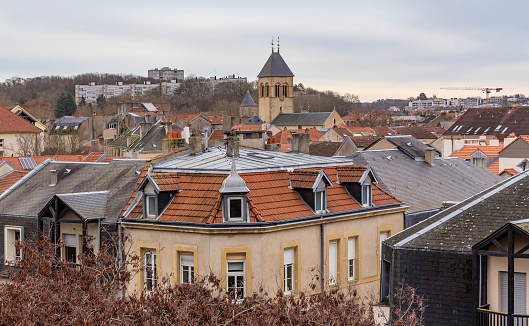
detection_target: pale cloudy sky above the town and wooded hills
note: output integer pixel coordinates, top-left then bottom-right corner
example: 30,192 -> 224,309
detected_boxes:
0,0 -> 529,102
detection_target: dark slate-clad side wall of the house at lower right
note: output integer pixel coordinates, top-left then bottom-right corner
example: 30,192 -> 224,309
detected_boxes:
383,246 -> 477,326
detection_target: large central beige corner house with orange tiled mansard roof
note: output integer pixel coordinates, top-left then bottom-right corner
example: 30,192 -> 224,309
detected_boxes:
121,142 -> 406,299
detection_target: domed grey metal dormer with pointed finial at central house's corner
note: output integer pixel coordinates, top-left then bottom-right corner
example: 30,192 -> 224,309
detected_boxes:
219,157 -> 250,222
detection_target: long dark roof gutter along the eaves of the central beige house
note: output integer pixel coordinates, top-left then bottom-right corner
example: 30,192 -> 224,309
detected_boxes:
120,204 -> 407,230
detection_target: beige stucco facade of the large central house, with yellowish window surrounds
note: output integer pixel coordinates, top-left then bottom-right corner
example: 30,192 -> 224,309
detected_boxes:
122,207 -> 406,297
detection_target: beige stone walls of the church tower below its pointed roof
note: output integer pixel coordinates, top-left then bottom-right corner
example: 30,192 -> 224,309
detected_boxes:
258,77 -> 294,123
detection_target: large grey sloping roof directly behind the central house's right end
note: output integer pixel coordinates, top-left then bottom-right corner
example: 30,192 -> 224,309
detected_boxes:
352,149 -> 503,213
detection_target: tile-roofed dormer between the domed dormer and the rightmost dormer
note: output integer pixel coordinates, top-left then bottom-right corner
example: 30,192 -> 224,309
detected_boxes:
290,169 -> 332,214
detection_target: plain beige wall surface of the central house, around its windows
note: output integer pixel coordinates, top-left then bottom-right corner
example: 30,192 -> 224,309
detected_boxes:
125,209 -> 403,296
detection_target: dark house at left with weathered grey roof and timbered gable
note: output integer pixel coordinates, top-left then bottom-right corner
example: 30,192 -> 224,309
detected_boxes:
0,160 -> 145,272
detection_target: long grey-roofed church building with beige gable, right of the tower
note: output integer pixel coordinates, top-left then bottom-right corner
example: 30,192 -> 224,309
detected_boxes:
271,110 -> 345,130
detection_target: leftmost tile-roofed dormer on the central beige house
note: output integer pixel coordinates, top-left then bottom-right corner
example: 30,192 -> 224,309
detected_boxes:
138,173 -> 180,219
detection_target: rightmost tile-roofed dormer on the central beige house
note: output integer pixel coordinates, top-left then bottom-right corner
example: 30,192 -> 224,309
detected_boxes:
336,165 -> 377,207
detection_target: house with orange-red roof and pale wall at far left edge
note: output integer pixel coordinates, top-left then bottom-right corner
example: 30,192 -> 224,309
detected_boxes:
0,106 -> 42,157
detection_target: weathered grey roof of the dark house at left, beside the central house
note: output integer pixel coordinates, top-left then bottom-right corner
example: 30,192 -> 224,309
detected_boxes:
0,160 -> 145,222
